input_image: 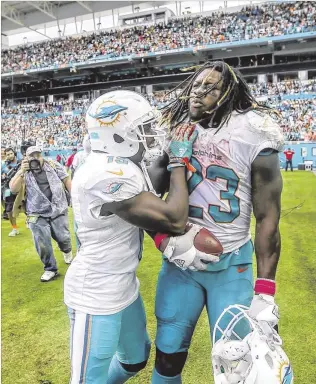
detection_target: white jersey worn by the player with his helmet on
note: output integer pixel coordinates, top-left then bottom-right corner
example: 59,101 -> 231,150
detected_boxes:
64,153 -> 147,315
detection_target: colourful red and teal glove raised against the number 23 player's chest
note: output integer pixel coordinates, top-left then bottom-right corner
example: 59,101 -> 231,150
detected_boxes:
168,123 -> 198,163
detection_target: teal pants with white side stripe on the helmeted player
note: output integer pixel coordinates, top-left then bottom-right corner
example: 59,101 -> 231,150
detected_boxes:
68,296 -> 150,384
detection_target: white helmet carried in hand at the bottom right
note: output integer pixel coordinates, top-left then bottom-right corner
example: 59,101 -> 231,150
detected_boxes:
212,305 -> 294,384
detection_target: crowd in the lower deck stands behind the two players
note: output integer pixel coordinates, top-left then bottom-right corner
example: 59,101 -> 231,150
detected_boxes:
1,82 -> 316,150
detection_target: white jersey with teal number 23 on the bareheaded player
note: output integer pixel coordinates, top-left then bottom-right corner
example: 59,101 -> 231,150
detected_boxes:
188,111 -> 283,253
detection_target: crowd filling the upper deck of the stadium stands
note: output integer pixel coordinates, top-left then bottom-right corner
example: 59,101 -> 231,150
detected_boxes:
2,1 -> 316,73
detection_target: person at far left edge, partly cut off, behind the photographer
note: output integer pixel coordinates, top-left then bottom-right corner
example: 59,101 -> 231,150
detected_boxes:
1,148 -> 21,237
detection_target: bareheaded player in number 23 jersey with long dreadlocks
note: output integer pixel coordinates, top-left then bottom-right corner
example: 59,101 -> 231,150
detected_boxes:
150,62 -> 283,384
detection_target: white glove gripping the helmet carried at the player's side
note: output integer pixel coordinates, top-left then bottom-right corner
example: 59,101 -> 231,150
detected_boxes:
248,293 -> 280,337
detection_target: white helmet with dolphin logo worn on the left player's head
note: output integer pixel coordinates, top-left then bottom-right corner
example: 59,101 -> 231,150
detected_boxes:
86,90 -> 166,160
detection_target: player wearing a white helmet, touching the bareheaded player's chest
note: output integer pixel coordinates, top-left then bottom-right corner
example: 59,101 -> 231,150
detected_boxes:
64,90 -> 207,384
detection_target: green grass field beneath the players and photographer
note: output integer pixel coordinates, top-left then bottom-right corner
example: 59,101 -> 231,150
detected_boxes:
2,172 -> 316,384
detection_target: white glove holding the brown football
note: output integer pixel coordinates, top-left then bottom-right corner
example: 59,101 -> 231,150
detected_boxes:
163,224 -> 219,271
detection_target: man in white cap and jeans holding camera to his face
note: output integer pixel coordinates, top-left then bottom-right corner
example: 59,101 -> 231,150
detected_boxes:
10,146 -> 72,282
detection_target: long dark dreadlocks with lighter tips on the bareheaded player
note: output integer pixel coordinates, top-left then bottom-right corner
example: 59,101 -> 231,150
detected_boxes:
161,61 -> 271,131
